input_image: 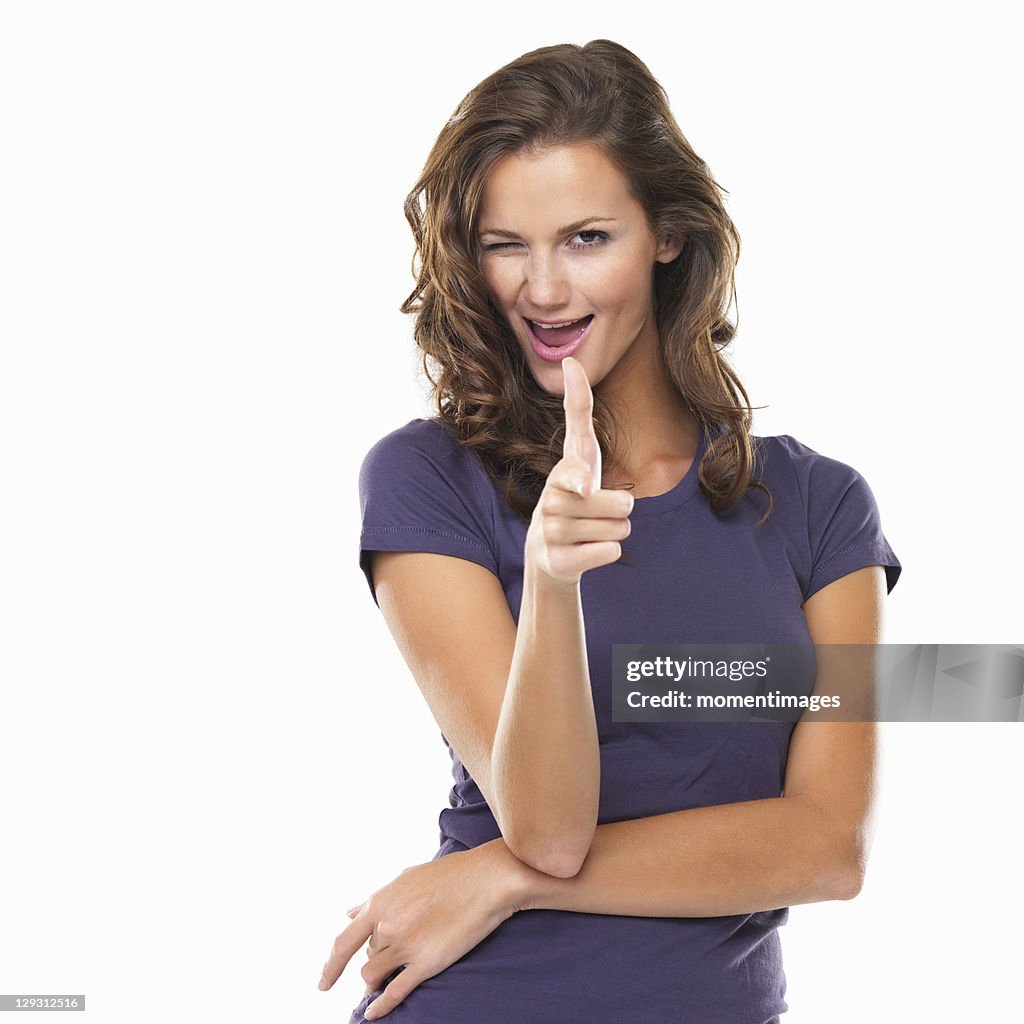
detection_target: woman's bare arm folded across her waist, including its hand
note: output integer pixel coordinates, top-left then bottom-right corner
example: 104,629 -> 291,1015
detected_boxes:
322,566 -> 886,1018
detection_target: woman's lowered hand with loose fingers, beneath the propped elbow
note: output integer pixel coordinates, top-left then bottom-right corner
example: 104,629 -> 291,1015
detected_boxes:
319,839 -> 531,1020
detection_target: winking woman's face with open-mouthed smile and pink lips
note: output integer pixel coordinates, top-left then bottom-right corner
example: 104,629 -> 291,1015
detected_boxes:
477,142 -> 682,394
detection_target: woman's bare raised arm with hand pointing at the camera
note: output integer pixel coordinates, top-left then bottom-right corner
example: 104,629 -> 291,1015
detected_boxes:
371,359 -> 633,878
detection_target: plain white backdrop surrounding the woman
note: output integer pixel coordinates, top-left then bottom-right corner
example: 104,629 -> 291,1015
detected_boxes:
0,0 -> 1024,1024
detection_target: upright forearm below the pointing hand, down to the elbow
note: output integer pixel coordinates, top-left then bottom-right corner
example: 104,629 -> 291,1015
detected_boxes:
490,563 -> 601,874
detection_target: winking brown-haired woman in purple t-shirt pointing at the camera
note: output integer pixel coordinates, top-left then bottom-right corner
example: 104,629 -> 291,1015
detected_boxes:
321,40 -> 900,1024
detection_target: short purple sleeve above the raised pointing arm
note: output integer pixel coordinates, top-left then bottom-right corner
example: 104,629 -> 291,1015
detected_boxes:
359,419 -> 498,603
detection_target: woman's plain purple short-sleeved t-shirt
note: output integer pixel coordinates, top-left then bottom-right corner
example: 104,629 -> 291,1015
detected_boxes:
350,419 -> 901,1024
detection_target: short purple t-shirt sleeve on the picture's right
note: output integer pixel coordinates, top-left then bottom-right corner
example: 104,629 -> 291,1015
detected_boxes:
786,436 -> 903,601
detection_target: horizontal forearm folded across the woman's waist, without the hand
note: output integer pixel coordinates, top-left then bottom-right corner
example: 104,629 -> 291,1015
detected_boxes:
495,796 -> 859,918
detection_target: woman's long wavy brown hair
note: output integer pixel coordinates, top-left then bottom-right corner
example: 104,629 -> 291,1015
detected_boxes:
400,39 -> 772,520
